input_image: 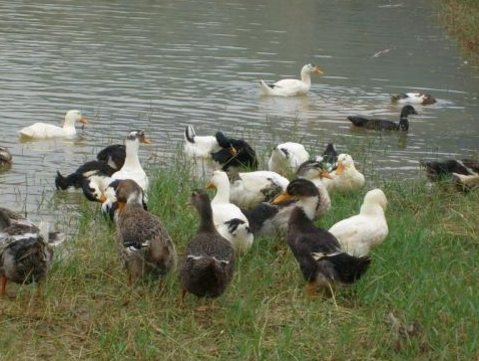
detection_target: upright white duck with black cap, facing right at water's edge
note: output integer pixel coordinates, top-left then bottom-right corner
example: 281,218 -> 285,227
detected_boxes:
111,130 -> 151,191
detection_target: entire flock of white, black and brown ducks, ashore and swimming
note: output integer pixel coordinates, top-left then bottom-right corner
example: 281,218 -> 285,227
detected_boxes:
0,64 -> 479,300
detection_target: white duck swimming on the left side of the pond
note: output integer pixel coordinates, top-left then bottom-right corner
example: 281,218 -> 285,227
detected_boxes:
18,110 -> 87,139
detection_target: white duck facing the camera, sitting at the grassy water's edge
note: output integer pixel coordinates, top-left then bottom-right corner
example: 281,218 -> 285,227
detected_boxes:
323,154 -> 365,193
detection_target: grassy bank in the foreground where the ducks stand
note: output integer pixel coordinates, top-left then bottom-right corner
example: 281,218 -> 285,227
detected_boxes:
0,145 -> 479,361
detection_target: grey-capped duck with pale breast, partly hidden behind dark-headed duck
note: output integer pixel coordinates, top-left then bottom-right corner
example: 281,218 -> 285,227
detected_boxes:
296,160 -> 333,220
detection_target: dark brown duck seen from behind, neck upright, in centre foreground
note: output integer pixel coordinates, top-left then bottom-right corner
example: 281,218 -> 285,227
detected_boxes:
180,189 -> 235,302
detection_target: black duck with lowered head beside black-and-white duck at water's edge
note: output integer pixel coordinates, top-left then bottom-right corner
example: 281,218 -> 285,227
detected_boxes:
211,132 -> 258,171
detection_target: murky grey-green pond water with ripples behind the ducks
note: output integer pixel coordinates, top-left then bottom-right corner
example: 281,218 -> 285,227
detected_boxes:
0,0 -> 479,224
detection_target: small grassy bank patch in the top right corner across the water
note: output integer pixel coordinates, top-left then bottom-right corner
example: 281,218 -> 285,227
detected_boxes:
440,0 -> 479,64
